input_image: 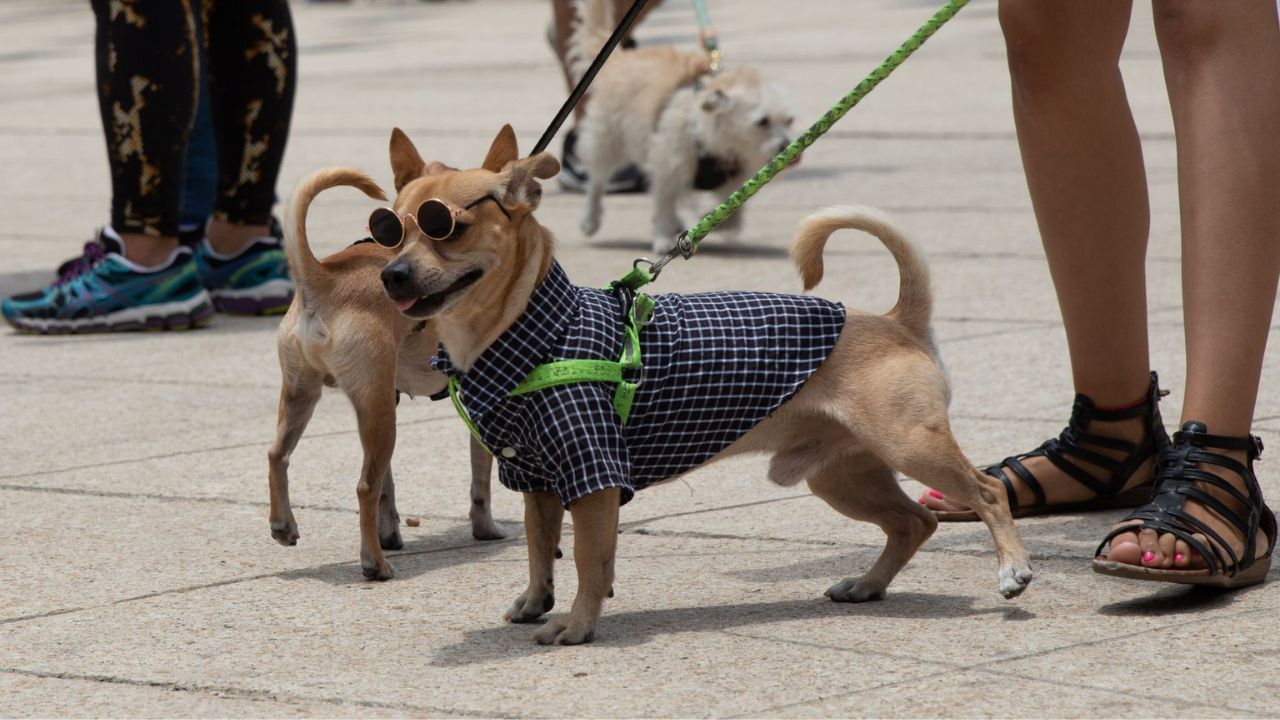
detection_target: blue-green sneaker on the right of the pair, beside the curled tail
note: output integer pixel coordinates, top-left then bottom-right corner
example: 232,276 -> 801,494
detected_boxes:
196,222 -> 293,315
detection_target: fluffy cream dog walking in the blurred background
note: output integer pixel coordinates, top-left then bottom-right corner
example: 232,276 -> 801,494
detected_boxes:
567,0 -> 794,252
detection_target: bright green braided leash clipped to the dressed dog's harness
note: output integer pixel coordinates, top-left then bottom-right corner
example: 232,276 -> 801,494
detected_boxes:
617,0 -> 969,290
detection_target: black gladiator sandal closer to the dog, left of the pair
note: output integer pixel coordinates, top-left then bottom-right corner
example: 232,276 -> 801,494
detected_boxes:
933,373 -> 1169,523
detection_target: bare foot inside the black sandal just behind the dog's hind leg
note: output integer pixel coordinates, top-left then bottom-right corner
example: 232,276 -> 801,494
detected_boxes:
919,380 -> 1164,512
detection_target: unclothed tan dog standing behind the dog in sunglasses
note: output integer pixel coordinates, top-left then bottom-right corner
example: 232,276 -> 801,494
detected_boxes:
268,162 -> 504,580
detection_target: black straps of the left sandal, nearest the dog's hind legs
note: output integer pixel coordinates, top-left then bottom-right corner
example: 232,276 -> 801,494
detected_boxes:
984,373 -> 1169,512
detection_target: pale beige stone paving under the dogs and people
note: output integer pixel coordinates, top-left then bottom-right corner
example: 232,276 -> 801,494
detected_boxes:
0,0 -> 1280,717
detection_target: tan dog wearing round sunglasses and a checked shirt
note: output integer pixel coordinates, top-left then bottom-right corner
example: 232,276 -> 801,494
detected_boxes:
383,126 -> 1032,644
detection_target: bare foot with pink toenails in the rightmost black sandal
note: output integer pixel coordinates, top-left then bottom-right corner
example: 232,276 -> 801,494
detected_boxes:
1100,423 -> 1270,573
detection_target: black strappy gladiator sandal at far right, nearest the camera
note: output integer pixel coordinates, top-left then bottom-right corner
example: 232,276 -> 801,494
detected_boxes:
1093,420 -> 1276,588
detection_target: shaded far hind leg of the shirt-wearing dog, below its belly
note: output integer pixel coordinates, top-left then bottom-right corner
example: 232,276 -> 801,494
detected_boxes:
809,455 -> 938,602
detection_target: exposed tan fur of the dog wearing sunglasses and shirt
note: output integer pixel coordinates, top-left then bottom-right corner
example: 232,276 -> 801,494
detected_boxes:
384,126 -> 1032,644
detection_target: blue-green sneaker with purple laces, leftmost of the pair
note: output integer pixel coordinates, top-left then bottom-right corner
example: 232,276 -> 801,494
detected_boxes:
0,227 -> 214,334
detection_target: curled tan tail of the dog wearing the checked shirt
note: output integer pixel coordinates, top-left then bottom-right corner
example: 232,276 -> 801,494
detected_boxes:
791,205 -> 933,338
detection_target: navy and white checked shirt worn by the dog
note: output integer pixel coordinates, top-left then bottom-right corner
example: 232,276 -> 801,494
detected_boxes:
431,263 -> 845,507
